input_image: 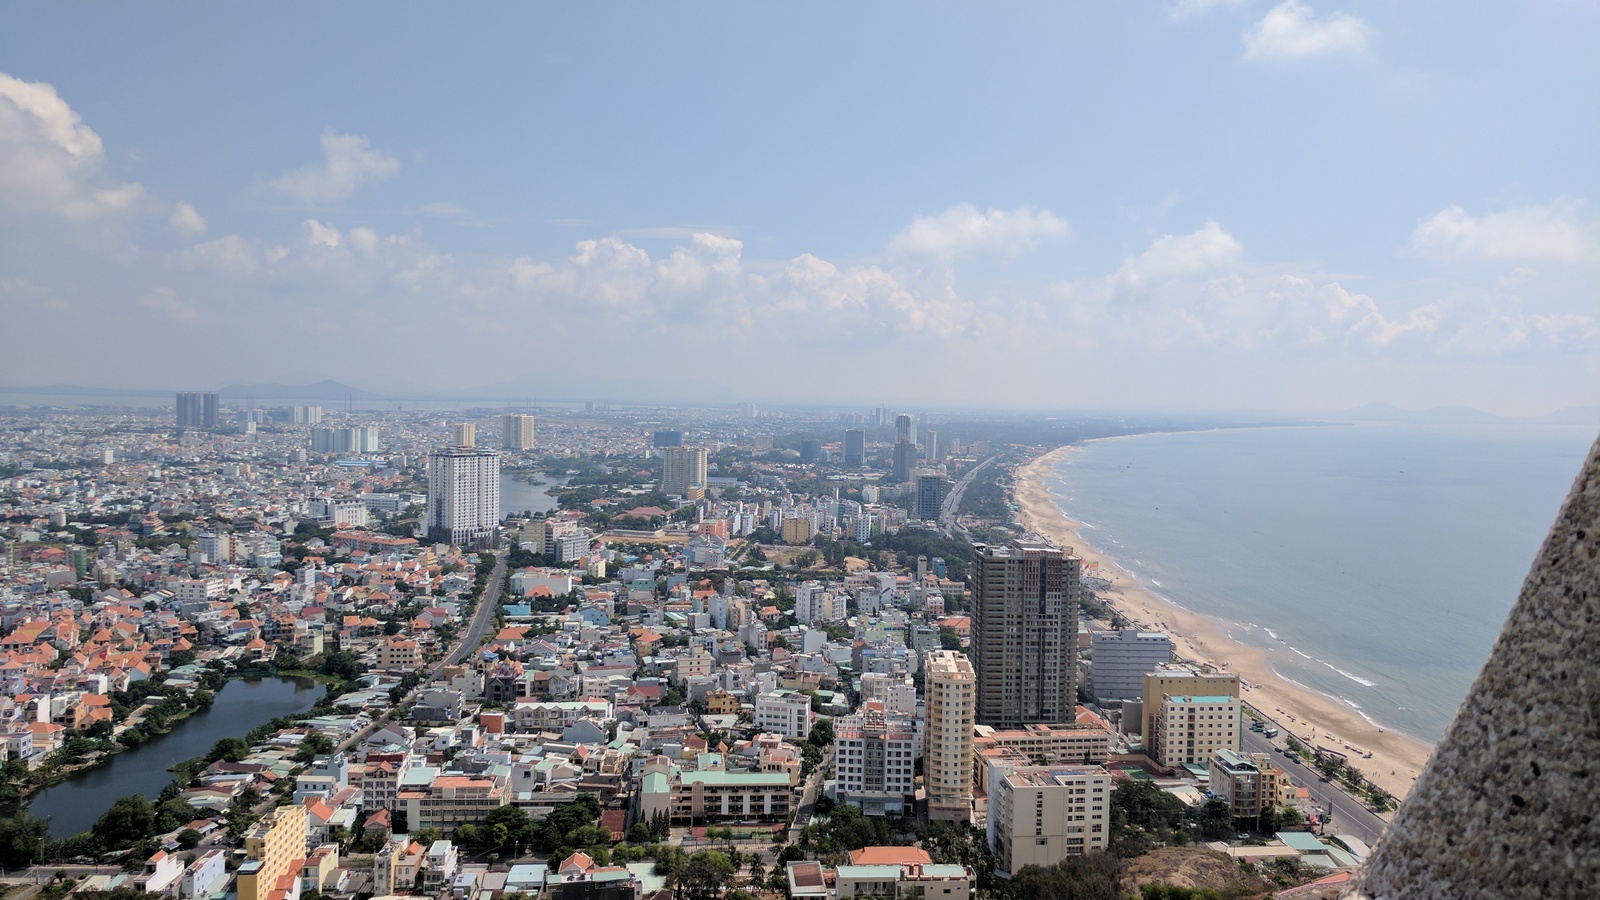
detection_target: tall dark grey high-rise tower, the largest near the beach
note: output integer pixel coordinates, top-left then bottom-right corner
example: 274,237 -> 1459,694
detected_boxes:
971,541 -> 1082,727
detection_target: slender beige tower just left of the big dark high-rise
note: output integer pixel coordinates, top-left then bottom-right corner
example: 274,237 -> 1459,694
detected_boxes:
925,650 -> 978,822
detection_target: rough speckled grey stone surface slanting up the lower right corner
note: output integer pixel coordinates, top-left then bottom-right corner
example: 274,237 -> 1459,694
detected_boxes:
1347,442 -> 1600,900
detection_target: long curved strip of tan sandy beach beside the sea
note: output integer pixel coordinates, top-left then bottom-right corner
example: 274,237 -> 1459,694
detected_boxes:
1016,447 -> 1432,798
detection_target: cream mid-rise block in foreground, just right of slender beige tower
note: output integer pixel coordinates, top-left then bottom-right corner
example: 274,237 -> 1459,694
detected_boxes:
989,762 -> 1110,876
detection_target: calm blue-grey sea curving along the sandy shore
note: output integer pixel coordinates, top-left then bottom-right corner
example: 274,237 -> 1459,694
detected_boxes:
1050,424 -> 1595,741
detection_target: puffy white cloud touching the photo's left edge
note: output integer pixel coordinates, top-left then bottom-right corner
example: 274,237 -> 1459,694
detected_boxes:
0,72 -> 144,219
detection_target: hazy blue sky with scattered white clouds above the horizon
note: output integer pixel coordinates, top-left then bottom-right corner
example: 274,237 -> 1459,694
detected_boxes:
0,0 -> 1600,415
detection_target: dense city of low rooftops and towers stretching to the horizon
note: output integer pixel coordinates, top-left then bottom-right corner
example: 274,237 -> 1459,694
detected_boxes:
0,392 -> 1392,900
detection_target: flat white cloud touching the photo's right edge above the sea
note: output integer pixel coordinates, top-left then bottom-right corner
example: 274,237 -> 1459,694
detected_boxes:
1411,200 -> 1600,263
